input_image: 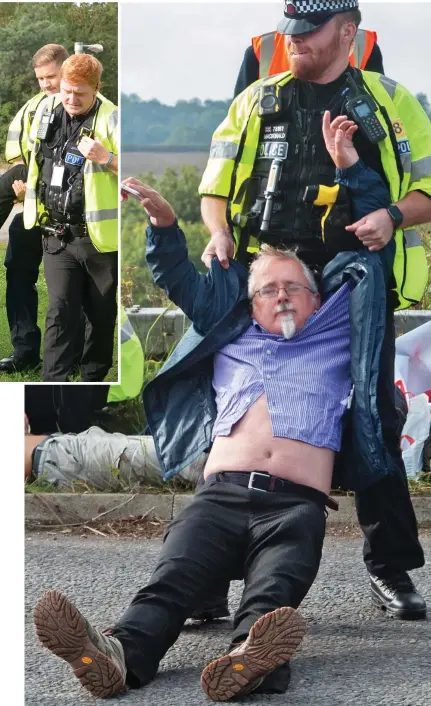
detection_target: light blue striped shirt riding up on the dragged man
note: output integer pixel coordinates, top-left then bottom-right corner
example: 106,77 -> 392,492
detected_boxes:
212,284 -> 351,451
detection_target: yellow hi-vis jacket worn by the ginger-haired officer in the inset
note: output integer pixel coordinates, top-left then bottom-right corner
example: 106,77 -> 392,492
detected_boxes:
24,93 -> 118,252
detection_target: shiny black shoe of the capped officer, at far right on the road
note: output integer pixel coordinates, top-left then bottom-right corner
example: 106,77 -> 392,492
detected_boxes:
370,571 -> 427,620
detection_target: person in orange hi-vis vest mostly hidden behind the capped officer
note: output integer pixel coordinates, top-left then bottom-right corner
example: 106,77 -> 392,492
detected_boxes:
234,6 -> 385,98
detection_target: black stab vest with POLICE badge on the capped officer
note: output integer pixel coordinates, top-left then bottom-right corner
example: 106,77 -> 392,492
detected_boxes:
248,80 -> 363,269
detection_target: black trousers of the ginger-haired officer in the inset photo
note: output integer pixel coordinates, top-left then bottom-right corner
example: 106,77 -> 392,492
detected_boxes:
43,236 -> 118,382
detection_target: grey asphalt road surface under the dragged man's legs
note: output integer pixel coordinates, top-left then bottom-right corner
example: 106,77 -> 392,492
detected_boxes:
26,534 -> 431,706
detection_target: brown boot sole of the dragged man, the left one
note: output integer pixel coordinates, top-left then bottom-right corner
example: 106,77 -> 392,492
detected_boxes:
33,591 -> 125,698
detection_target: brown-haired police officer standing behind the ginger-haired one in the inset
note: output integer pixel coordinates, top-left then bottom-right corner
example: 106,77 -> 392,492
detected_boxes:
0,44 -> 71,373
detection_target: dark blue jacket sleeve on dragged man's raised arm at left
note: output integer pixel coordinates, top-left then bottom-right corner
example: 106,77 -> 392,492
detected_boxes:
146,223 -> 247,333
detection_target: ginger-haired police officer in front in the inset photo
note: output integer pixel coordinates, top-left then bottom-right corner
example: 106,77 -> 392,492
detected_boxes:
24,54 -> 118,382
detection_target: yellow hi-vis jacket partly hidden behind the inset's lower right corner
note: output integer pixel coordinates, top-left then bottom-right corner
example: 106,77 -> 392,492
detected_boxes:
108,307 -> 144,402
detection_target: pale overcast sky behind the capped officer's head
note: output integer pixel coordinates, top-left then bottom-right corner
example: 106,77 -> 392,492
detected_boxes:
120,0 -> 431,105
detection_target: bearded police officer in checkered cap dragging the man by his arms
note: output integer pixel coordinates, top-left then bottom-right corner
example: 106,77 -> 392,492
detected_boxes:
200,0 -> 431,618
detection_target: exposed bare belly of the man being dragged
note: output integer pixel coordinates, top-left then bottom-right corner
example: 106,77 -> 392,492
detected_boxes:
204,395 -> 335,494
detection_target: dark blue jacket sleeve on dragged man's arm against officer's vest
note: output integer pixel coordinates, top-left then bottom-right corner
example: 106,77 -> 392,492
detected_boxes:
335,159 -> 391,221
